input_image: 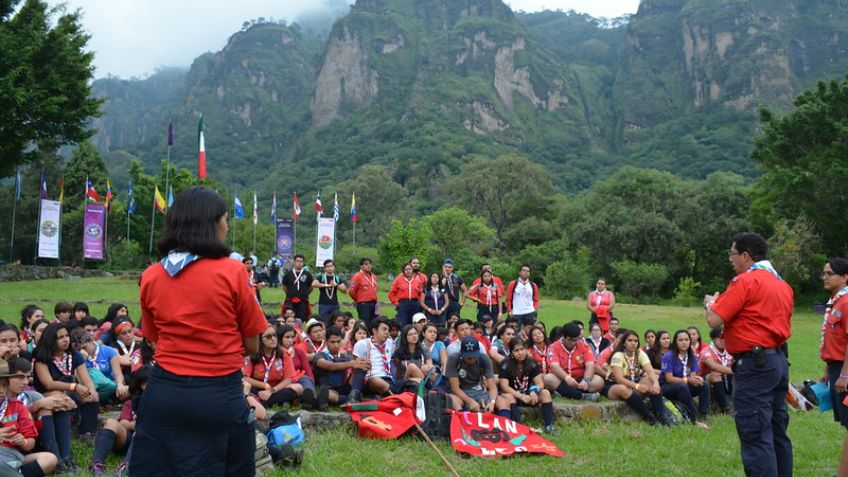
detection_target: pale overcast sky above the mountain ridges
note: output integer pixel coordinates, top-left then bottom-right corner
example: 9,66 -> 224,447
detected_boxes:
56,0 -> 639,78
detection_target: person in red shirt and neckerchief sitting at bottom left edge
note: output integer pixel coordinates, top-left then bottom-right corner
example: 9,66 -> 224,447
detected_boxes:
0,358 -> 58,477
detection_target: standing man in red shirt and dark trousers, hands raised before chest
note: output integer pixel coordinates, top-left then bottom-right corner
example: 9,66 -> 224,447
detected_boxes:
704,233 -> 795,477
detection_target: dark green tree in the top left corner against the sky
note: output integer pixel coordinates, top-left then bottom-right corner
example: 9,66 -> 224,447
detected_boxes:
0,0 -> 102,177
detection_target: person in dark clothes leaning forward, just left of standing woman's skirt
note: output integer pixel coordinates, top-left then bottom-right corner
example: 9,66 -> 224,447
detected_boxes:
88,364 -> 153,476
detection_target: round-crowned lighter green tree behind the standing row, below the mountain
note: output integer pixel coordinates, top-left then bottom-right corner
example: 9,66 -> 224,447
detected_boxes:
447,154 -> 555,248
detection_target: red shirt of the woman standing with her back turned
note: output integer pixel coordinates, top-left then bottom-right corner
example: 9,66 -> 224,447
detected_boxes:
140,257 -> 268,376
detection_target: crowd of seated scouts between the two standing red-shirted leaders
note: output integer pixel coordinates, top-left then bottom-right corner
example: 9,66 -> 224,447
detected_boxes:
244,309 -> 733,433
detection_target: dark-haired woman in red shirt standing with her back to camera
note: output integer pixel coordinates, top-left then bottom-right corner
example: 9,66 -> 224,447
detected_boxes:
130,186 -> 268,476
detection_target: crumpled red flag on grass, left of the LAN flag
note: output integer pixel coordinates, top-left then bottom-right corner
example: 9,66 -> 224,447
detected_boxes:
347,393 -> 424,439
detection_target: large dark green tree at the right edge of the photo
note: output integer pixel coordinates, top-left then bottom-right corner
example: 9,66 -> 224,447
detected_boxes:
751,77 -> 848,255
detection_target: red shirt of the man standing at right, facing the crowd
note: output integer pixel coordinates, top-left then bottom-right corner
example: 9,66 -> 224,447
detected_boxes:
712,269 -> 795,354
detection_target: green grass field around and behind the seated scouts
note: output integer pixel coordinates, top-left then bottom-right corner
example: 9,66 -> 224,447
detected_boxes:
0,278 -> 844,477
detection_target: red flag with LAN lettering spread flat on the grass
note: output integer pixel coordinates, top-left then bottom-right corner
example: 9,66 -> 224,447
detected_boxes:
451,412 -> 565,457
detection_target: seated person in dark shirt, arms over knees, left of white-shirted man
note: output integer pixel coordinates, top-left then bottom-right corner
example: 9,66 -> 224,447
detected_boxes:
312,326 -> 371,411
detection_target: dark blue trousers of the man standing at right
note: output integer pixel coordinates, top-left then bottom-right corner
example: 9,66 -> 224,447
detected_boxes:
733,353 -> 792,477
